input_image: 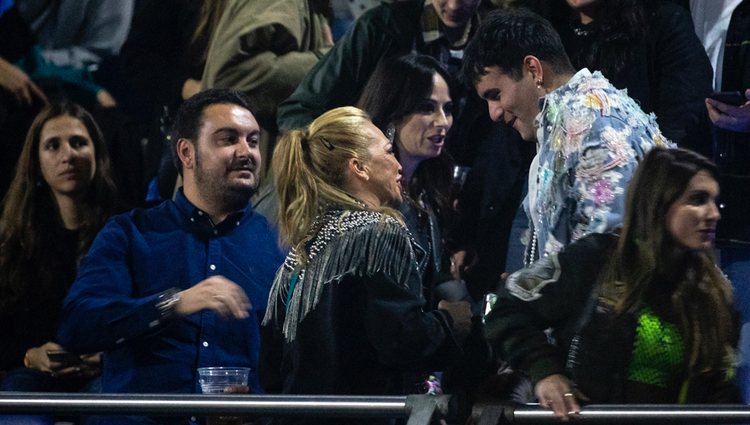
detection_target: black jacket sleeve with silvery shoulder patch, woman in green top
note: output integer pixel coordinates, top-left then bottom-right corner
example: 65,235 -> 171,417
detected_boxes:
485,234 -> 611,383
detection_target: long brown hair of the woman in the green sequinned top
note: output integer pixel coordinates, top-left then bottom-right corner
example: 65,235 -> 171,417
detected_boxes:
602,148 -> 736,375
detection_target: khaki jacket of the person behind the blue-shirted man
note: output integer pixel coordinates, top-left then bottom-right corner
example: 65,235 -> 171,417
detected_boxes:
202,0 -> 332,128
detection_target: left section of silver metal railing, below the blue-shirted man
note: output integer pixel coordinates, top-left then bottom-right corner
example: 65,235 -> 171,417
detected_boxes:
0,392 -> 449,425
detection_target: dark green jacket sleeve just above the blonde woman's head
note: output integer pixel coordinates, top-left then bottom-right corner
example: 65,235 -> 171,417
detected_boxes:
277,5 -> 406,132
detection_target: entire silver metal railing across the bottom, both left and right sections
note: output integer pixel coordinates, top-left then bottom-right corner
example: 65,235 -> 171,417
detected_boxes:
0,392 -> 750,425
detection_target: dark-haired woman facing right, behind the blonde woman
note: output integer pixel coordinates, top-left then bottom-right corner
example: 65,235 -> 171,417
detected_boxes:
358,55 -> 464,304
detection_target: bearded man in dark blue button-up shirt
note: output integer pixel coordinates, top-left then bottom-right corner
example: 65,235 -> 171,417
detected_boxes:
59,89 -> 283,424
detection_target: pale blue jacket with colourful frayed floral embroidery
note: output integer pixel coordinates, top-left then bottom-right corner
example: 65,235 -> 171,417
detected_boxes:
524,68 -> 672,263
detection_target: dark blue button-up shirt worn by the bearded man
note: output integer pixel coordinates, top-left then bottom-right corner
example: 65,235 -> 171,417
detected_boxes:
58,191 -> 284,402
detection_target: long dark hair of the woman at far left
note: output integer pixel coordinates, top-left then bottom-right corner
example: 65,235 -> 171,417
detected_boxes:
0,102 -> 117,310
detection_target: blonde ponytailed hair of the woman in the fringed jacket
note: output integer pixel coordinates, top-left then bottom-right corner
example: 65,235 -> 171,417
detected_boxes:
272,106 -> 401,262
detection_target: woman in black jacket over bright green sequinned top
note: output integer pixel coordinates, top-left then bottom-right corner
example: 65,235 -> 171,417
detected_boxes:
487,148 -> 738,417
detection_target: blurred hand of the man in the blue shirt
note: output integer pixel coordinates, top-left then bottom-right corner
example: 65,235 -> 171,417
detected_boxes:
175,276 -> 253,320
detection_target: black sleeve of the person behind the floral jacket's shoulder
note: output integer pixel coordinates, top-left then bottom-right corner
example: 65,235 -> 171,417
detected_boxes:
650,2 -> 713,154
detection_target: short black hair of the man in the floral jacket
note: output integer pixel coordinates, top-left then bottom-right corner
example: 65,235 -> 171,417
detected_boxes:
463,8 -> 575,86
